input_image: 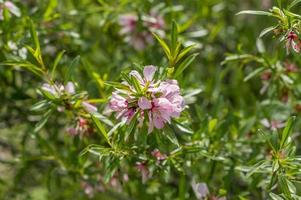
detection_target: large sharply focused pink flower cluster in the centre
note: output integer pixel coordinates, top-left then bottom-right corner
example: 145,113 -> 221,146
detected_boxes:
109,65 -> 185,133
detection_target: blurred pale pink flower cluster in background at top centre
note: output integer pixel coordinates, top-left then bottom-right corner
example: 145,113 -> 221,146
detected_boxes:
119,11 -> 165,50
